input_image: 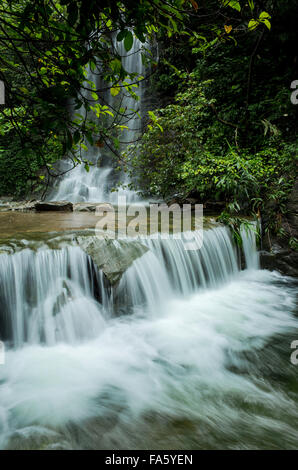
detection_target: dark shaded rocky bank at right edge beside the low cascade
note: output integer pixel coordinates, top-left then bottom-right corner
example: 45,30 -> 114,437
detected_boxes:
260,179 -> 298,277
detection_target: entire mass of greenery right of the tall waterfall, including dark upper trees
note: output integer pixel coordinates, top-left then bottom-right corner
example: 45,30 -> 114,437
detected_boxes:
128,0 -> 298,252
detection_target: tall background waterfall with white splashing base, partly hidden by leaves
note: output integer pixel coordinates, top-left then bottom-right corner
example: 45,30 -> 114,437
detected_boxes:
49,37 -> 144,203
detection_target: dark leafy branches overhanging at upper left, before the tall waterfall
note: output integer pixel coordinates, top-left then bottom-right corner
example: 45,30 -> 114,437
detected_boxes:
0,0 -> 192,192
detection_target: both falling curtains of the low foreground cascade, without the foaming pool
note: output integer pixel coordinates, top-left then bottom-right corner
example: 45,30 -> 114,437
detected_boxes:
0,227 -> 270,347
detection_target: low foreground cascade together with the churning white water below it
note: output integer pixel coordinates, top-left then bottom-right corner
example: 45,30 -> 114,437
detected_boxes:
0,226 -> 298,449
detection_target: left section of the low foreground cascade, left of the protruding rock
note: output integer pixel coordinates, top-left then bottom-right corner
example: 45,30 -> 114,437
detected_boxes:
0,247 -> 107,347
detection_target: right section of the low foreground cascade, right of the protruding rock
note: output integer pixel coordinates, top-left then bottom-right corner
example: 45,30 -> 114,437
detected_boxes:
118,227 -> 239,310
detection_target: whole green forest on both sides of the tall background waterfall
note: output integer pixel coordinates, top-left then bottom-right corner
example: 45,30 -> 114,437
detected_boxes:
0,0 -> 298,250
